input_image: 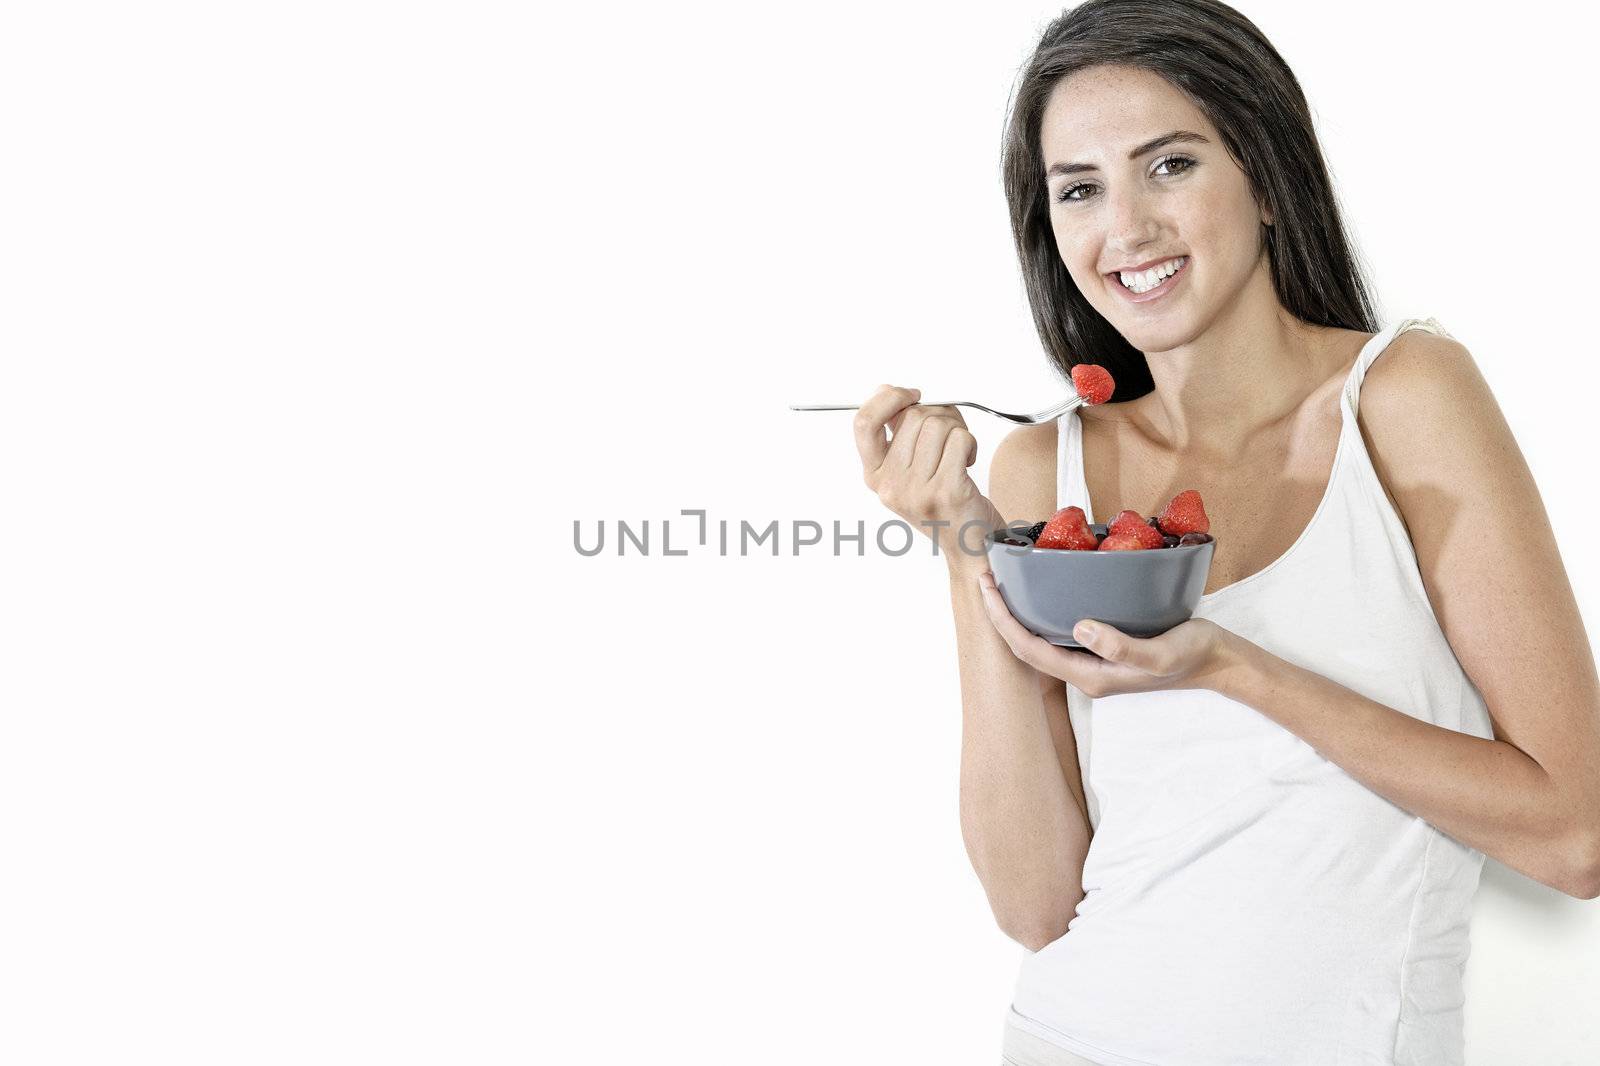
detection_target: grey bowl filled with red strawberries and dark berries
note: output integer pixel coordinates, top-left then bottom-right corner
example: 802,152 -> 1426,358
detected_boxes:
986,488 -> 1216,648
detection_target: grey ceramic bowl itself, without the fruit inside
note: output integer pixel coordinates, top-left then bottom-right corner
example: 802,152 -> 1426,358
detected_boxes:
984,523 -> 1216,648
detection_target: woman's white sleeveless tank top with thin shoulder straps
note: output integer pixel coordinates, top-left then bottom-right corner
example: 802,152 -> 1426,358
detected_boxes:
1010,319 -> 1493,1066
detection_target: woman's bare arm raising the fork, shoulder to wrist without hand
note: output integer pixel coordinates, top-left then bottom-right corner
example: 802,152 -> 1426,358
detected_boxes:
946,426 -> 1090,951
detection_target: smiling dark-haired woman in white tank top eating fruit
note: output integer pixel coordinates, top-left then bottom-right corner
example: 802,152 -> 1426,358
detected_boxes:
854,0 -> 1600,1066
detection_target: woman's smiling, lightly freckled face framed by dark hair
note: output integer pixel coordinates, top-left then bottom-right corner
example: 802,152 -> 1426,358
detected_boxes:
1040,66 -> 1272,352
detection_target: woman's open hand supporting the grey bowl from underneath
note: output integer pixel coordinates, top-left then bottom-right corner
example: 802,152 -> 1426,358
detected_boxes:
978,570 -> 1237,698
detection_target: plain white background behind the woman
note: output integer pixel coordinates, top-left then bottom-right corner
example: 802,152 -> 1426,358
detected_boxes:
0,0 -> 1600,1066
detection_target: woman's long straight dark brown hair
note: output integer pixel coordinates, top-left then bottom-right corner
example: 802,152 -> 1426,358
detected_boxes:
1002,0 -> 1378,402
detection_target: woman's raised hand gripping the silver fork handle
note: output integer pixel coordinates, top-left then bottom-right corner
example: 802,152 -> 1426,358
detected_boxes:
854,386 -> 1005,570
